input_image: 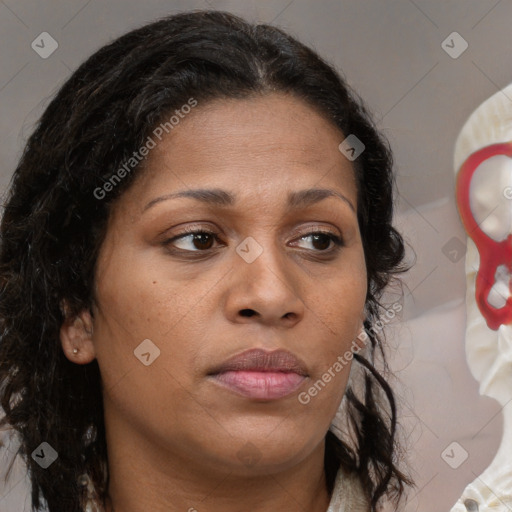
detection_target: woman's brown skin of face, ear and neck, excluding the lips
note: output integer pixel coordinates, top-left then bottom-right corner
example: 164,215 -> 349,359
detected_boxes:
61,93 -> 367,512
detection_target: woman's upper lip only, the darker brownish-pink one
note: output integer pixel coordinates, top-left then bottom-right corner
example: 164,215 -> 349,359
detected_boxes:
209,348 -> 308,376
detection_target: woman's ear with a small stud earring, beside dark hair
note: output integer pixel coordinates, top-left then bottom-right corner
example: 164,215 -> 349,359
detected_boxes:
60,305 -> 96,364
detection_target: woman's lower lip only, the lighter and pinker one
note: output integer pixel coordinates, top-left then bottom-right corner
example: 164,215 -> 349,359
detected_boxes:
213,371 -> 306,400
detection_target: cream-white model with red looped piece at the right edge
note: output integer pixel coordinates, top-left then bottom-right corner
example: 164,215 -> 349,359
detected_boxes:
451,85 -> 512,512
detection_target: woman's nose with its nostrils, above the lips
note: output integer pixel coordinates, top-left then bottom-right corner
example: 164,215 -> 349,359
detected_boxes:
225,237 -> 308,328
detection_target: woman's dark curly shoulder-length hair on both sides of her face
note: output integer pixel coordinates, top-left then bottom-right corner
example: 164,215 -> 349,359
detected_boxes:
0,11 -> 412,512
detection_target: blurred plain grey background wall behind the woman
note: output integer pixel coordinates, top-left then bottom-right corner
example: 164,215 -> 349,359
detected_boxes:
0,0 -> 512,512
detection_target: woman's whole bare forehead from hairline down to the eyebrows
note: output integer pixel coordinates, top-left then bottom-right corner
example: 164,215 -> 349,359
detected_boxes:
117,93 -> 356,213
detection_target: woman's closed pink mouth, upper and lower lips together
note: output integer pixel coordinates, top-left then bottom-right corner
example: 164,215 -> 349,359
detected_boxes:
209,349 -> 308,400
